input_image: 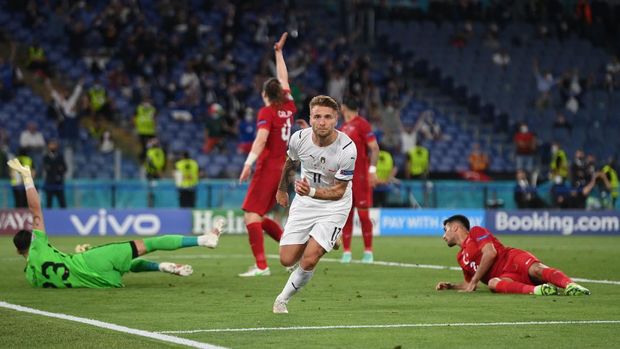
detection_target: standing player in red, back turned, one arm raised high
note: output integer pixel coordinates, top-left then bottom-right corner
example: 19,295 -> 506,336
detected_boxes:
239,33 -> 297,277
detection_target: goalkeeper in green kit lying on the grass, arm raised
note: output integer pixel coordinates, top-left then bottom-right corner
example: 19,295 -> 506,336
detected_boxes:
8,159 -> 224,288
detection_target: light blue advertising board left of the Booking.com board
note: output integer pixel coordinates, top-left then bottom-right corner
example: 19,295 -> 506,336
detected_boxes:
379,209 -> 485,236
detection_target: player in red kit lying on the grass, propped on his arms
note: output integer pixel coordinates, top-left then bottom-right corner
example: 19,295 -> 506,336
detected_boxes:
435,215 -> 590,296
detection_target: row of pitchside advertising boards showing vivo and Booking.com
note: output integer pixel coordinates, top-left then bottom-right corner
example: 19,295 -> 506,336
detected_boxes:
0,208 -> 620,236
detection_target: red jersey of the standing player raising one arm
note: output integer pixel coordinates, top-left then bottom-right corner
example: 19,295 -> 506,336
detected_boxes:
256,91 -> 297,163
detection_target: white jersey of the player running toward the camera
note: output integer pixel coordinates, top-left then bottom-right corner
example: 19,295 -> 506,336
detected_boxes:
288,127 -> 357,215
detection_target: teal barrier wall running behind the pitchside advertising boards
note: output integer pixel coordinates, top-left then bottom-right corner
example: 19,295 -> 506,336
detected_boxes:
0,179 -> 588,210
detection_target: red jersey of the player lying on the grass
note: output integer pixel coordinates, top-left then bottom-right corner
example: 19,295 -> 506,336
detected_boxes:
456,227 -> 510,284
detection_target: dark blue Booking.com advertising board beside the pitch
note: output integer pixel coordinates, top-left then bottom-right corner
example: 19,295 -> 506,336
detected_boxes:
486,210 -> 620,235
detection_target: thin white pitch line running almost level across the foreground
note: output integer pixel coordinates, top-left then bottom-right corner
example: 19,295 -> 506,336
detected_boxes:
158,320 -> 620,334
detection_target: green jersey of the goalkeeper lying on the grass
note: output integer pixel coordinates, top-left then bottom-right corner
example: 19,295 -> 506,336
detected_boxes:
26,230 -> 123,288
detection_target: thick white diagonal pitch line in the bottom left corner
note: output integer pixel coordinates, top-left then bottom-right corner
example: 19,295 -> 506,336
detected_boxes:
0,301 -> 224,349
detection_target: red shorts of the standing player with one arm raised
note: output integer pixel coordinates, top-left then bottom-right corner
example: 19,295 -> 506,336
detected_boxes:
241,162 -> 284,216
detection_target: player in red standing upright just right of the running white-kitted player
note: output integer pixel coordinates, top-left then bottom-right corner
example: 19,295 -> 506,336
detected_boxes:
340,100 -> 379,263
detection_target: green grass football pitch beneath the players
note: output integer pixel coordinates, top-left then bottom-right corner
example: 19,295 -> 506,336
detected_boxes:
0,235 -> 620,348
